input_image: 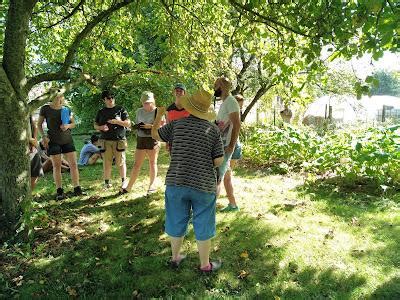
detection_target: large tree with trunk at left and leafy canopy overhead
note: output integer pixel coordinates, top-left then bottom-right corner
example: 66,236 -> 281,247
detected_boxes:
0,0 -> 399,239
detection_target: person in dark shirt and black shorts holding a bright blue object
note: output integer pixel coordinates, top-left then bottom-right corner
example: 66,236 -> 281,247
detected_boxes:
38,92 -> 84,200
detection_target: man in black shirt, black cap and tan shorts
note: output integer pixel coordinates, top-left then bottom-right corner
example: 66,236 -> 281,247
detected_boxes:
94,91 -> 131,189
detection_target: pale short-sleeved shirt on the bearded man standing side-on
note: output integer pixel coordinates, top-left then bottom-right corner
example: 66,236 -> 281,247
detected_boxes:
217,95 -> 240,146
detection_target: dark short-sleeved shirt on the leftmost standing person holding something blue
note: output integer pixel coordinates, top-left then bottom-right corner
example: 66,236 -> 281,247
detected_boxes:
39,104 -> 73,145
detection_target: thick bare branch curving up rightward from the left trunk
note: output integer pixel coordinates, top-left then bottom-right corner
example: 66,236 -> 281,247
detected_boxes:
26,0 -> 135,91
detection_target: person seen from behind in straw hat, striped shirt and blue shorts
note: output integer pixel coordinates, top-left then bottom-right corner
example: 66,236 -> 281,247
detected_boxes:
151,90 -> 224,273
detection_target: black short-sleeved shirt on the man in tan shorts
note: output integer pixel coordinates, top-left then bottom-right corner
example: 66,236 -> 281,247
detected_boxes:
95,106 -> 129,141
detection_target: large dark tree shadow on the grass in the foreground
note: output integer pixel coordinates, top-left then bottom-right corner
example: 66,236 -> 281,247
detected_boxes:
1,200 -> 372,299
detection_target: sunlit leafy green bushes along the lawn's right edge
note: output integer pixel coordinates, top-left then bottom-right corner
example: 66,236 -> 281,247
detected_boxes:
244,125 -> 400,185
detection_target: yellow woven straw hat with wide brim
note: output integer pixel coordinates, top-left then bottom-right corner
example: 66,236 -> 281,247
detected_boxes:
181,90 -> 216,121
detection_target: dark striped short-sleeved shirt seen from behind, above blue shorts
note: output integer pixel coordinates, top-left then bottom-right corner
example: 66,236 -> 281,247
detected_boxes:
158,115 -> 224,193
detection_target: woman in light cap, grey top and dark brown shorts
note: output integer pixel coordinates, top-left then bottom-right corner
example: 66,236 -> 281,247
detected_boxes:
121,91 -> 165,195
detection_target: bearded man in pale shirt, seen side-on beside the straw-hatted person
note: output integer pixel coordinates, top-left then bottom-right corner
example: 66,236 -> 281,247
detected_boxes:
214,77 -> 240,212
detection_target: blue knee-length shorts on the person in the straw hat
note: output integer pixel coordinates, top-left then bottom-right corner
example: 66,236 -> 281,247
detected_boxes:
165,185 -> 216,241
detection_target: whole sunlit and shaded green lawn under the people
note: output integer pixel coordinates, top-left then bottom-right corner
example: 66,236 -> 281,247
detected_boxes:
0,137 -> 400,299
